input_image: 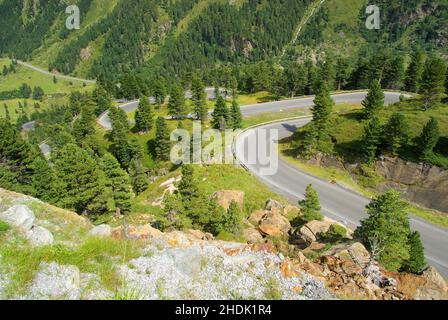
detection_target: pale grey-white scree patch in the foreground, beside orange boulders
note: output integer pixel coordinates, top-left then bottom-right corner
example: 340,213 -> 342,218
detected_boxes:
120,236 -> 332,300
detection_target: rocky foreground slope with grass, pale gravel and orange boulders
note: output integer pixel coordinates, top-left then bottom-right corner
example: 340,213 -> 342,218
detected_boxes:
0,189 -> 448,300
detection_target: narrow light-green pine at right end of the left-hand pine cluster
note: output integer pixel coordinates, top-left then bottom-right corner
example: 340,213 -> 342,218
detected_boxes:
100,153 -> 132,215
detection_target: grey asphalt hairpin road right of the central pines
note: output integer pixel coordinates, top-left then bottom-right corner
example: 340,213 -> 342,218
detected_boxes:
234,92 -> 448,277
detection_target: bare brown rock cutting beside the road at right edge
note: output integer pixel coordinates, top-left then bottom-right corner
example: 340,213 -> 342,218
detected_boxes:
375,158 -> 448,212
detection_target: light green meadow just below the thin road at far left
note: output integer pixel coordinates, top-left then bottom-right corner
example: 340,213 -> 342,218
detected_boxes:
0,59 -> 93,95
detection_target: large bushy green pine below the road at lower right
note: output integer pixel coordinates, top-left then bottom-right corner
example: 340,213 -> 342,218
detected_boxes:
355,189 -> 410,271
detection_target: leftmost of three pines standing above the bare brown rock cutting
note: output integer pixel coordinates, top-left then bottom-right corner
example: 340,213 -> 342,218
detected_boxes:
361,115 -> 383,164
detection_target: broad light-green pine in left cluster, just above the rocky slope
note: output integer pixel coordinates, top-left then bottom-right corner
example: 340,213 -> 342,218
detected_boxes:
55,144 -> 113,214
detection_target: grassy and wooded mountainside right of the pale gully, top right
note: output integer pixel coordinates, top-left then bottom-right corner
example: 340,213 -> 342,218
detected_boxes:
288,0 -> 448,57
